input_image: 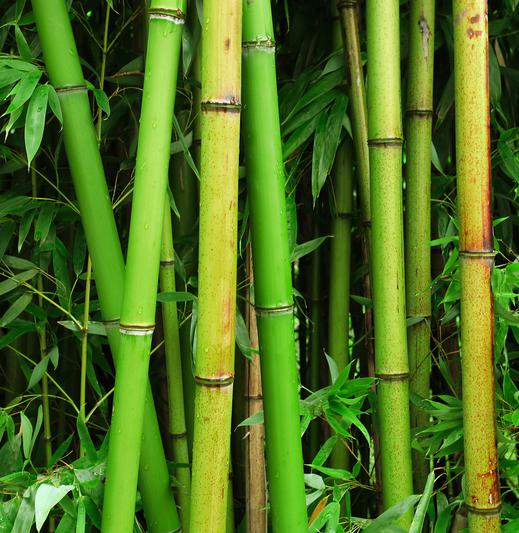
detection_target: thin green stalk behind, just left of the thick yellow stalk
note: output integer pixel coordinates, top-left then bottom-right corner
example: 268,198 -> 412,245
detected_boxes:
160,200 -> 191,532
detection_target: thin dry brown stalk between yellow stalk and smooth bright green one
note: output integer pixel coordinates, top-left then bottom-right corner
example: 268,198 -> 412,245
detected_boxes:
245,246 -> 267,533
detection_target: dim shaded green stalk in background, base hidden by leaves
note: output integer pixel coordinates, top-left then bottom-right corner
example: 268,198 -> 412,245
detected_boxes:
328,139 -> 353,470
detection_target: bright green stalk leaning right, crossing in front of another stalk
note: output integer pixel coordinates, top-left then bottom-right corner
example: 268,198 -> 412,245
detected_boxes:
102,0 -> 185,533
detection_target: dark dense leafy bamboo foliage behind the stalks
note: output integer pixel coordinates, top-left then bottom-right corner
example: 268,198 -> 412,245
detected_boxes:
0,0 -> 519,533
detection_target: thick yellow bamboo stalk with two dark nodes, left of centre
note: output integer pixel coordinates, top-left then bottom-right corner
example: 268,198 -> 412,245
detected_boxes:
190,0 -> 241,533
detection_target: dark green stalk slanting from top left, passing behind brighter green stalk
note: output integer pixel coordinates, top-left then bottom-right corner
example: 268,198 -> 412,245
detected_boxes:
32,0 -> 180,533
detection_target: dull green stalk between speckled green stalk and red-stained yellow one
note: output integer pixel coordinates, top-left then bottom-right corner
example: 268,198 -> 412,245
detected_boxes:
405,0 -> 434,492
